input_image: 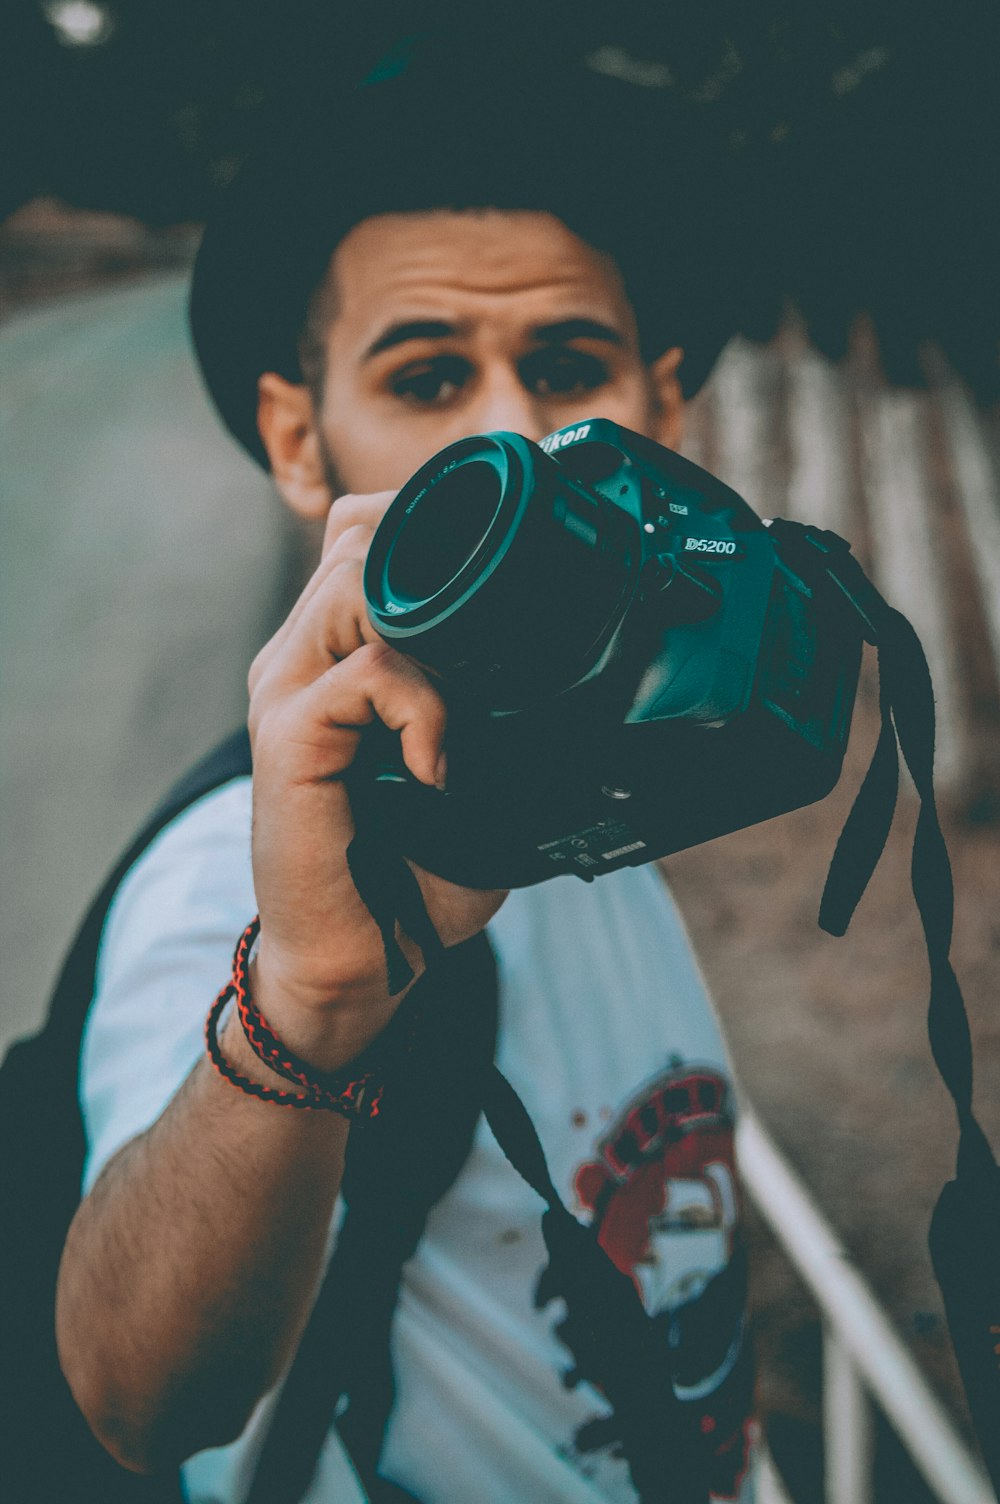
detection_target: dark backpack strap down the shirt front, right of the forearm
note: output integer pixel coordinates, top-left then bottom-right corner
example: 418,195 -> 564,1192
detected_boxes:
245,934 -> 498,1504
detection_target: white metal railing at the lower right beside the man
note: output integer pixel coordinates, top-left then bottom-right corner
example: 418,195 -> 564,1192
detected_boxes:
737,1108 -> 997,1504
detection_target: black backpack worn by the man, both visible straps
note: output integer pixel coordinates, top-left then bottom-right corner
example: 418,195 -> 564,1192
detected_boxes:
0,729 -> 496,1504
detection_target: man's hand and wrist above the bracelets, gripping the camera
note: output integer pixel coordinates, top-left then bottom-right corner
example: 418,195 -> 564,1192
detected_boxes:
242,492 -> 505,1069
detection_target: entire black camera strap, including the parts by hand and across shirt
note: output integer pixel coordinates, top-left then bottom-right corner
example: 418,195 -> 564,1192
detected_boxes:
342,519 -> 1000,1504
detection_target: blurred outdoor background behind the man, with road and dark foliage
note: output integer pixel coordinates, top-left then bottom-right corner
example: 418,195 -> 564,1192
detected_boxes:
0,0 -> 1000,1504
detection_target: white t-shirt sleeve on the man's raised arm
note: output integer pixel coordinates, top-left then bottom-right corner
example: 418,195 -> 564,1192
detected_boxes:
80,778 -> 256,1194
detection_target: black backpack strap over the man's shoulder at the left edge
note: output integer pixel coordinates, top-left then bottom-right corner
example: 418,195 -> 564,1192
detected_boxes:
0,729 -> 250,1504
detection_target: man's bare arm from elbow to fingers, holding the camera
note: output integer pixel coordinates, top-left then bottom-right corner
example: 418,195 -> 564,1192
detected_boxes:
57,495 -> 504,1471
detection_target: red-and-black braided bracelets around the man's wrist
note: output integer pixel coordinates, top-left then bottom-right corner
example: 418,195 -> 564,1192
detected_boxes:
205,919 -> 382,1119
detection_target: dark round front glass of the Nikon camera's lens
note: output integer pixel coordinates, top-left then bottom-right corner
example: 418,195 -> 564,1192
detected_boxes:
385,460 -> 501,605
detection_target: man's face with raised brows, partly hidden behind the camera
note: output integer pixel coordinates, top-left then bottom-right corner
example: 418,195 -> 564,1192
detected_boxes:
260,211 -> 681,514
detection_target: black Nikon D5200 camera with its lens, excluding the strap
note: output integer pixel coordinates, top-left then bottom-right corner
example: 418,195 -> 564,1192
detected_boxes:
359,418 -> 862,887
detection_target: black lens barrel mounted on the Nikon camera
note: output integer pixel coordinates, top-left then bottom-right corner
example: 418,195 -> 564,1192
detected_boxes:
364,433 -> 641,710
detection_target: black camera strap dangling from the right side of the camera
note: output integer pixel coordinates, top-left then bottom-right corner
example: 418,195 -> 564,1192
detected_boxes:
770,520 -> 1000,1490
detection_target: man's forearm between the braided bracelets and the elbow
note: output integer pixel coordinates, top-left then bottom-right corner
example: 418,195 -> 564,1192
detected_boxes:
57,1024 -> 347,1471
